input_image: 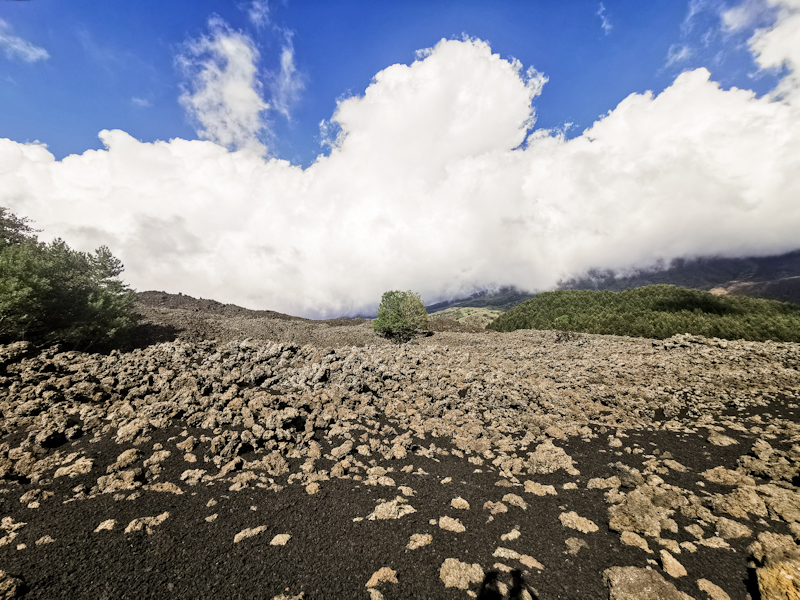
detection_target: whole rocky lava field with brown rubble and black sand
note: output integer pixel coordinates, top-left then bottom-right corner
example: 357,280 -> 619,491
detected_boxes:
0,295 -> 800,600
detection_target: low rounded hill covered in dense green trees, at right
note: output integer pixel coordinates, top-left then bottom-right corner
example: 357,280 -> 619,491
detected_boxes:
487,285 -> 800,342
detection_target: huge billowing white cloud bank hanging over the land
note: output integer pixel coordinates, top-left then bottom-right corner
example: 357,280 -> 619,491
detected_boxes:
0,5 -> 800,317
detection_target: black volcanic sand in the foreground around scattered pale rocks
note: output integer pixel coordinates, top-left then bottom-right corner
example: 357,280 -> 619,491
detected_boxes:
0,406 -> 789,600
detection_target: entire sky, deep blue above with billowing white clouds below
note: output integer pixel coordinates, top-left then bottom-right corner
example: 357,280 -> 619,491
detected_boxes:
0,0 -> 800,317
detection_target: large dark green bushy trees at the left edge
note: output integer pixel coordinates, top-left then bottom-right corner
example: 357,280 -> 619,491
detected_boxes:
0,207 -> 136,349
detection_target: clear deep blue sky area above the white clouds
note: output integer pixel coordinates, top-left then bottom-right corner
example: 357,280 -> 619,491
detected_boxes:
0,0 -> 777,166
